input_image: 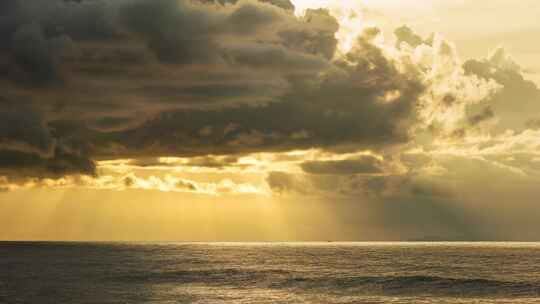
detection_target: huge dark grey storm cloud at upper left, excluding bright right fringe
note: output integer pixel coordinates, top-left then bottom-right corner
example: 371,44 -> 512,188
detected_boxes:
0,0 -> 424,177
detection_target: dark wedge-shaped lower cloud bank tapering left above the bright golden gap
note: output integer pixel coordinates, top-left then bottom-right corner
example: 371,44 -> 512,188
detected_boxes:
104,57 -> 422,159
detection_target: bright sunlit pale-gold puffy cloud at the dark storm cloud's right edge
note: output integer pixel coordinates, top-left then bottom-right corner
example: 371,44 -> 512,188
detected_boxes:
396,28 -> 502,137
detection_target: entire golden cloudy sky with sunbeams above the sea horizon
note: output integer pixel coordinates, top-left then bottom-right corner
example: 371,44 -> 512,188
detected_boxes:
0,0 -> 540,241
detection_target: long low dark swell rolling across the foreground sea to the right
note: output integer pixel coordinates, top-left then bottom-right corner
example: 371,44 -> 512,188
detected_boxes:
116,268 -> 540,297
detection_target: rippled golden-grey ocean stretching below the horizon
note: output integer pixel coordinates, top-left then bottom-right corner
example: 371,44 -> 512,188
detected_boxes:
0,242 -> 540,304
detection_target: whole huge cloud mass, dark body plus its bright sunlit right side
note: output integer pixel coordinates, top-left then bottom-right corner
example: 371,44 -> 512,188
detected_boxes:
0,0 -> 538,202
